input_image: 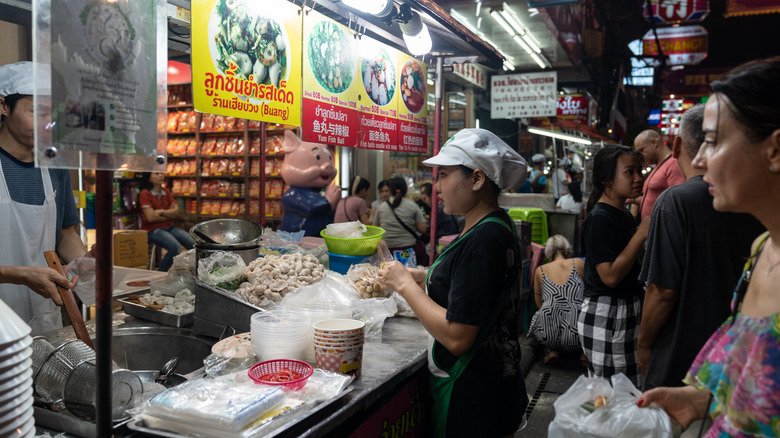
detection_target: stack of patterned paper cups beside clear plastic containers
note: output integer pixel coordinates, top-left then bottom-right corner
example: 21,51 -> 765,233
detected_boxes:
313,319 -> 365,377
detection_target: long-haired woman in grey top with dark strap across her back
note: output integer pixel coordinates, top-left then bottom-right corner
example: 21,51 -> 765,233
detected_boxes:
373,177 -> 428,266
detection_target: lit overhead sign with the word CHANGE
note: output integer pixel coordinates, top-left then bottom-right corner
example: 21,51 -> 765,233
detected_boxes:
642,26 -> 707,65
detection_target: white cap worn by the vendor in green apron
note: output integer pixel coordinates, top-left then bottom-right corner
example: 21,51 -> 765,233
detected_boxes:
423,129 -> 528,190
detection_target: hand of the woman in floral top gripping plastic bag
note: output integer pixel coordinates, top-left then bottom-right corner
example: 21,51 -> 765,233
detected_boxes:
637,386 -> 710,430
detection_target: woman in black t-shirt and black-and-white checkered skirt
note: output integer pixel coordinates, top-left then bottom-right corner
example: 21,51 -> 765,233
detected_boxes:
577,145 -> 650,385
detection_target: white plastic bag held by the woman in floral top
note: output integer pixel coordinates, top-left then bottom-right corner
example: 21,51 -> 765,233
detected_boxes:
547,374 -> 673,438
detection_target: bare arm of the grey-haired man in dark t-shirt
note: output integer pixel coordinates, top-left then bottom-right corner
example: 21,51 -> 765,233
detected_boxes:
637,284 -> 680,374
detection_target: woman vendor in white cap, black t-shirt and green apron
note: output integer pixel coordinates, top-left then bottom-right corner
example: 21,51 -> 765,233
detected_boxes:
379,129 -> 528,437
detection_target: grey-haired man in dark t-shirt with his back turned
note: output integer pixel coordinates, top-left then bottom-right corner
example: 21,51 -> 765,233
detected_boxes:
637,105 -> 763,390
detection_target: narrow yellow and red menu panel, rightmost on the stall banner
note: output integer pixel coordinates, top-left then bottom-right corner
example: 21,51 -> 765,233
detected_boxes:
396,52 -> 428,153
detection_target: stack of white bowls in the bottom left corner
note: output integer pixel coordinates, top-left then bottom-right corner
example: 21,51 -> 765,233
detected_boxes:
0,300 -> 35,437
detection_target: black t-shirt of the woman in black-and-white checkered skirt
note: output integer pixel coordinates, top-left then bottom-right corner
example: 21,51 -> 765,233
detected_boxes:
583,202 -> 642,298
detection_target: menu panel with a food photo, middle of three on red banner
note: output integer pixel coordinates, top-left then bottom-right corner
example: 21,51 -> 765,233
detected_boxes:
358,38 -> 399,151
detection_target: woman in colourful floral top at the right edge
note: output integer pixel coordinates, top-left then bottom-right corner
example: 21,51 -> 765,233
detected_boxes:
639,57 -> 780,437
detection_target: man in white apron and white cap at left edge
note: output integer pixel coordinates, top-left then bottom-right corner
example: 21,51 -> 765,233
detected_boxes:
0,62 -> 85,335
